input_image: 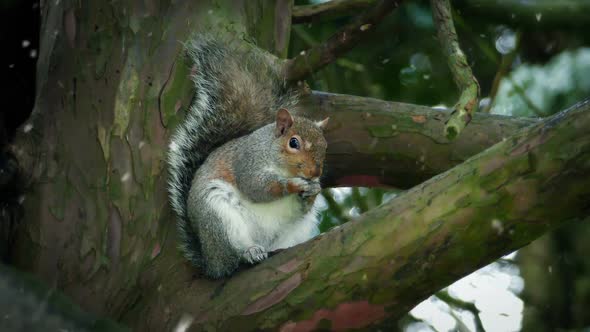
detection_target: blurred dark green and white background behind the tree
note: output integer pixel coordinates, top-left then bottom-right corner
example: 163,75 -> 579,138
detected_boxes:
0,0 -> 590,332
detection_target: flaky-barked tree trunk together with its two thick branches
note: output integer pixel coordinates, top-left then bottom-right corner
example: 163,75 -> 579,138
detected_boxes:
8,0 -> 590,331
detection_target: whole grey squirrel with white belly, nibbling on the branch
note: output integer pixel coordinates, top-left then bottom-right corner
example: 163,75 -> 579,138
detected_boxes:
168,35 -> 328,278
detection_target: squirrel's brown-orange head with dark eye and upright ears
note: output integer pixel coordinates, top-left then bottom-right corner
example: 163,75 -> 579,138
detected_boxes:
274,108 -> 329,179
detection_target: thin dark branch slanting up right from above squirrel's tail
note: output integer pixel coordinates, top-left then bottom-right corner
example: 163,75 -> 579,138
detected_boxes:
285,0 -> 402,81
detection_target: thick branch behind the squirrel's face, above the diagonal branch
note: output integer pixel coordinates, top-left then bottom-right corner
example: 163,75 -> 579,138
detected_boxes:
302,91 -> 538,189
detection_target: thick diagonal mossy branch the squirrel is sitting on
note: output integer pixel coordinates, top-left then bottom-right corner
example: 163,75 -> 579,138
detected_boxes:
136,102 -> 590,331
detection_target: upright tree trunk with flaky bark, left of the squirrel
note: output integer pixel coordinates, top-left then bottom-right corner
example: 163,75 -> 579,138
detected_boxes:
13,0 -> 291,318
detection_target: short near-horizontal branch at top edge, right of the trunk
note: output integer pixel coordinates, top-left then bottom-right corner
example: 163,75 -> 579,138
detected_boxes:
293,0 -> 377,24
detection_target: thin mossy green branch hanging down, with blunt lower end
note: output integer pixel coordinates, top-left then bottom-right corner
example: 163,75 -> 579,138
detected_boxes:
430,0 -> 479,139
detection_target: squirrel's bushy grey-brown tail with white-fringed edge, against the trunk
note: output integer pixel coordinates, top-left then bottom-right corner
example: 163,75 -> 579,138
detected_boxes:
168,35 -> 297,266
